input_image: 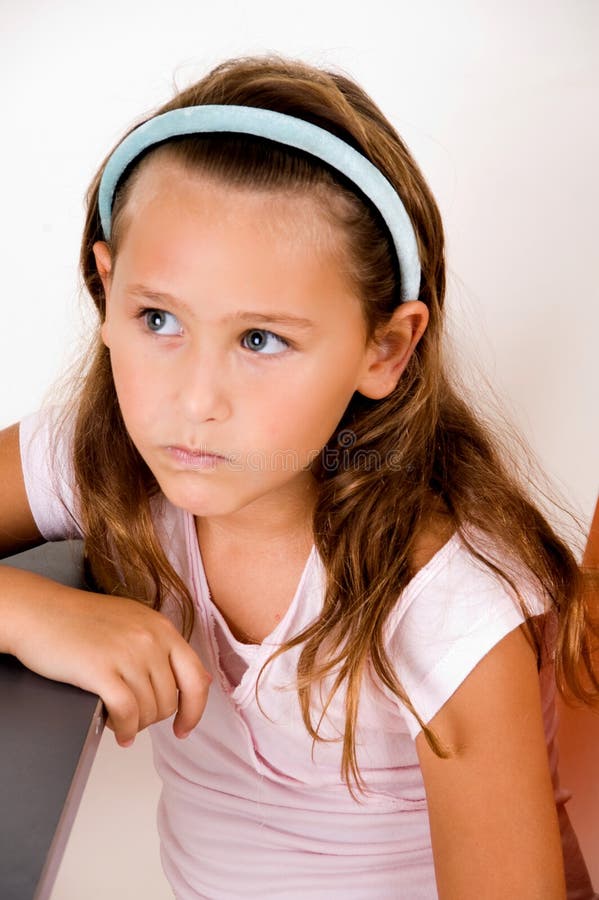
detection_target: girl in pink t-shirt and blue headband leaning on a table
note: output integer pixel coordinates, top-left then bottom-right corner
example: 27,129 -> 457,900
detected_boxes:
0,56 -> 599,900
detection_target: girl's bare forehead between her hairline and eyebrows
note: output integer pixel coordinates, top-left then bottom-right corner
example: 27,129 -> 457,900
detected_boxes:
113,152 -> 361,308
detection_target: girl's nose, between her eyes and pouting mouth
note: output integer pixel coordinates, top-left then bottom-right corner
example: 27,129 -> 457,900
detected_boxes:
177,344 -> 231,424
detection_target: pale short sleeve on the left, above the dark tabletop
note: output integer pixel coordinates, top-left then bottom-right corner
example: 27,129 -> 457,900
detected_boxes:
19,406 -> 82,541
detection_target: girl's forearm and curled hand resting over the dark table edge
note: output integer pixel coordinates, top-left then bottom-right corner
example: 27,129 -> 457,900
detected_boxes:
2,567 -> 211,746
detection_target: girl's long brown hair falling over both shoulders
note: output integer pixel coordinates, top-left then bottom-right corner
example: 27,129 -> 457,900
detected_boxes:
68,54 -> 599,790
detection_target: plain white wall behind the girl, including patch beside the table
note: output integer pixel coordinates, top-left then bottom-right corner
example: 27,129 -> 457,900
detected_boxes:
0,0 -> 599,900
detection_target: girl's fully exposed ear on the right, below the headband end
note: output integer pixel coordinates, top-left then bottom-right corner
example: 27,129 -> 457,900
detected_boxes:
356,300 -> 428,400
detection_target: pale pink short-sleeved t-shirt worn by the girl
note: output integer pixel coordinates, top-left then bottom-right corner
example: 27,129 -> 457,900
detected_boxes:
21,414 -> 596,900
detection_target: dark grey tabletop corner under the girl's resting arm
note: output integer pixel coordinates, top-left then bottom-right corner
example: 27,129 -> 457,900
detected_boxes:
0,541 -> 105,900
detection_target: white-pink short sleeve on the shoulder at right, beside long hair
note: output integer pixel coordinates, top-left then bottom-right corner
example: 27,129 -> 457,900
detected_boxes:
387,533 -> 547,738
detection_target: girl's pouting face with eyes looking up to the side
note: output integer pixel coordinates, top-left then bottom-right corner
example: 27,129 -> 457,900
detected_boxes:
94,160 -> 426,516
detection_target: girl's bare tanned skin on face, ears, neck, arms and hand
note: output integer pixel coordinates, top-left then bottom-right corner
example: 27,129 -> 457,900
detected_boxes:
0,160 -> 565,900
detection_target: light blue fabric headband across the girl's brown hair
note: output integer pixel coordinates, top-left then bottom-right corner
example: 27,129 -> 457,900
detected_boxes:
98,104 -> 420,301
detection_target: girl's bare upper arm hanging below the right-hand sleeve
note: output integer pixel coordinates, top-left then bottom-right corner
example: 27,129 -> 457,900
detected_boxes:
416,626 -> 566,900
